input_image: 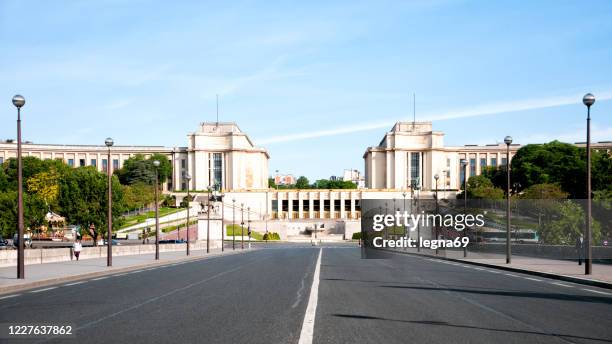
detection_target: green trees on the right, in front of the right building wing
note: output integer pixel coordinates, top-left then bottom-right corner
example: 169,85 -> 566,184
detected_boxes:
457,141 -> 612,245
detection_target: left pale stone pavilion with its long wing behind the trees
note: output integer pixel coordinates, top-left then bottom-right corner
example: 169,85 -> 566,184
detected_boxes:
0,122 -> 269,191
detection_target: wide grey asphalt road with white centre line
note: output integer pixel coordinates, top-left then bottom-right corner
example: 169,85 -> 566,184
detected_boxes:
0,244 -> 612,343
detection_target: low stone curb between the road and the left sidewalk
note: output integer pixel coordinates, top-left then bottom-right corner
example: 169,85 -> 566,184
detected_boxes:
0,249 -> 252,296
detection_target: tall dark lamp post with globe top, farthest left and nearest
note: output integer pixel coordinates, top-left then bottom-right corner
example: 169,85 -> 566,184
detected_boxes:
13,94 -> 25,279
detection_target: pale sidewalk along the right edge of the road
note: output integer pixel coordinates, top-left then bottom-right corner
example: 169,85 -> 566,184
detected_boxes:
397,249 -> 612,289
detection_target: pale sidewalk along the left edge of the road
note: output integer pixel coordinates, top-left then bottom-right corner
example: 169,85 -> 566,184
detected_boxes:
0,248 -> 246,295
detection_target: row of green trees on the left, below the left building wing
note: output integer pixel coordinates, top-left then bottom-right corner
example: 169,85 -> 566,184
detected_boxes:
0,154 -> 172,245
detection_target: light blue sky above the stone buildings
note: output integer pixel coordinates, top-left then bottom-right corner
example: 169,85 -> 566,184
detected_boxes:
0,0 -> 612,180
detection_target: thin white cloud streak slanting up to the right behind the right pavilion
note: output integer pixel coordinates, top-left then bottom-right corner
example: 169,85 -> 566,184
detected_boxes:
259,91 -> 612,144
